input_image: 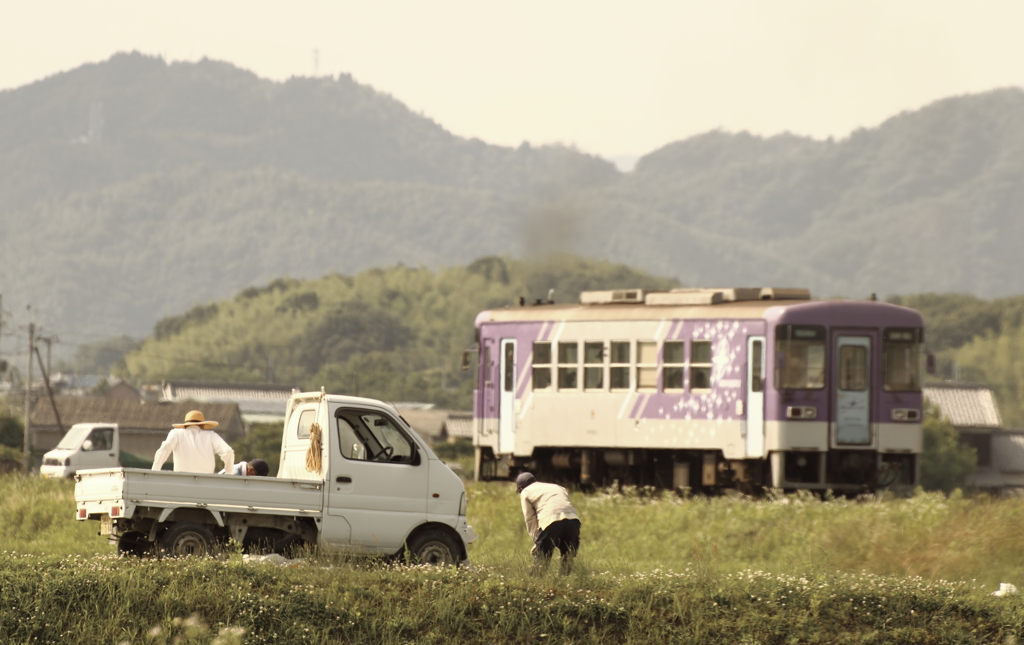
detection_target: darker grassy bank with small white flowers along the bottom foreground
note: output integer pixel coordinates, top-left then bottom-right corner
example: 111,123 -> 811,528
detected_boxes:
0,553 -> 1024,644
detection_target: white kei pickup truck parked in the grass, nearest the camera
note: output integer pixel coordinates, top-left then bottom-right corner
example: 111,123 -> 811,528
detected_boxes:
75,392 -> 476,565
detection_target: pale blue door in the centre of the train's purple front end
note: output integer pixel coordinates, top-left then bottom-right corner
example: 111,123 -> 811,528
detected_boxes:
834,336 -> 871,445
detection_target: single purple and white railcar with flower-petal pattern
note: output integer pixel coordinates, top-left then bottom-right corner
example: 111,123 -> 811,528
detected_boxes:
473,289 -> 924,492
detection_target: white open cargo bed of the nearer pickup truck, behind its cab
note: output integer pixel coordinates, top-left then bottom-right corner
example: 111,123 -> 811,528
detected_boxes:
75,468 -> 324,520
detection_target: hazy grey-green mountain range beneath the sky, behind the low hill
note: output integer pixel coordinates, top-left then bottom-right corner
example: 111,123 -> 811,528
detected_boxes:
0,53 -> 1024,342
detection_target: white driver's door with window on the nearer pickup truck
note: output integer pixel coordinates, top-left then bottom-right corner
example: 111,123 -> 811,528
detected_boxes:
323,406 -> 429,553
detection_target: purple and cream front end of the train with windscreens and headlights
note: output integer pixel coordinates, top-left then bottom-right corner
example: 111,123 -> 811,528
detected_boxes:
765,321 -> 924,492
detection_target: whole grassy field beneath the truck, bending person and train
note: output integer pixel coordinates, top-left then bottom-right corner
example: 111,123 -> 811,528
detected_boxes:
0,476 -> 1024,644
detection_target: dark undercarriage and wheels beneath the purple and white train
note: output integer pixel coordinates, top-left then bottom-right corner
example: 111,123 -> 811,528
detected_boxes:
476,447 -> 918,495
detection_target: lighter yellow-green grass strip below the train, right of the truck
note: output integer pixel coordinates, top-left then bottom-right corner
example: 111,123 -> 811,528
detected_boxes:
468,484 -> 1024,589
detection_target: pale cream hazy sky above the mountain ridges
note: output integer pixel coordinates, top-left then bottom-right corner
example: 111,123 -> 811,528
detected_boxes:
0,0 -> 1024,157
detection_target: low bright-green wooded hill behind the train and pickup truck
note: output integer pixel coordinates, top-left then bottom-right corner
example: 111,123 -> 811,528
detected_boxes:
121,256 -> 677,409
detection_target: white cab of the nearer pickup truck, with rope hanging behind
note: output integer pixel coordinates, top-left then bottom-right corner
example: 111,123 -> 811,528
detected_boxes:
278,393 -> 475,559
